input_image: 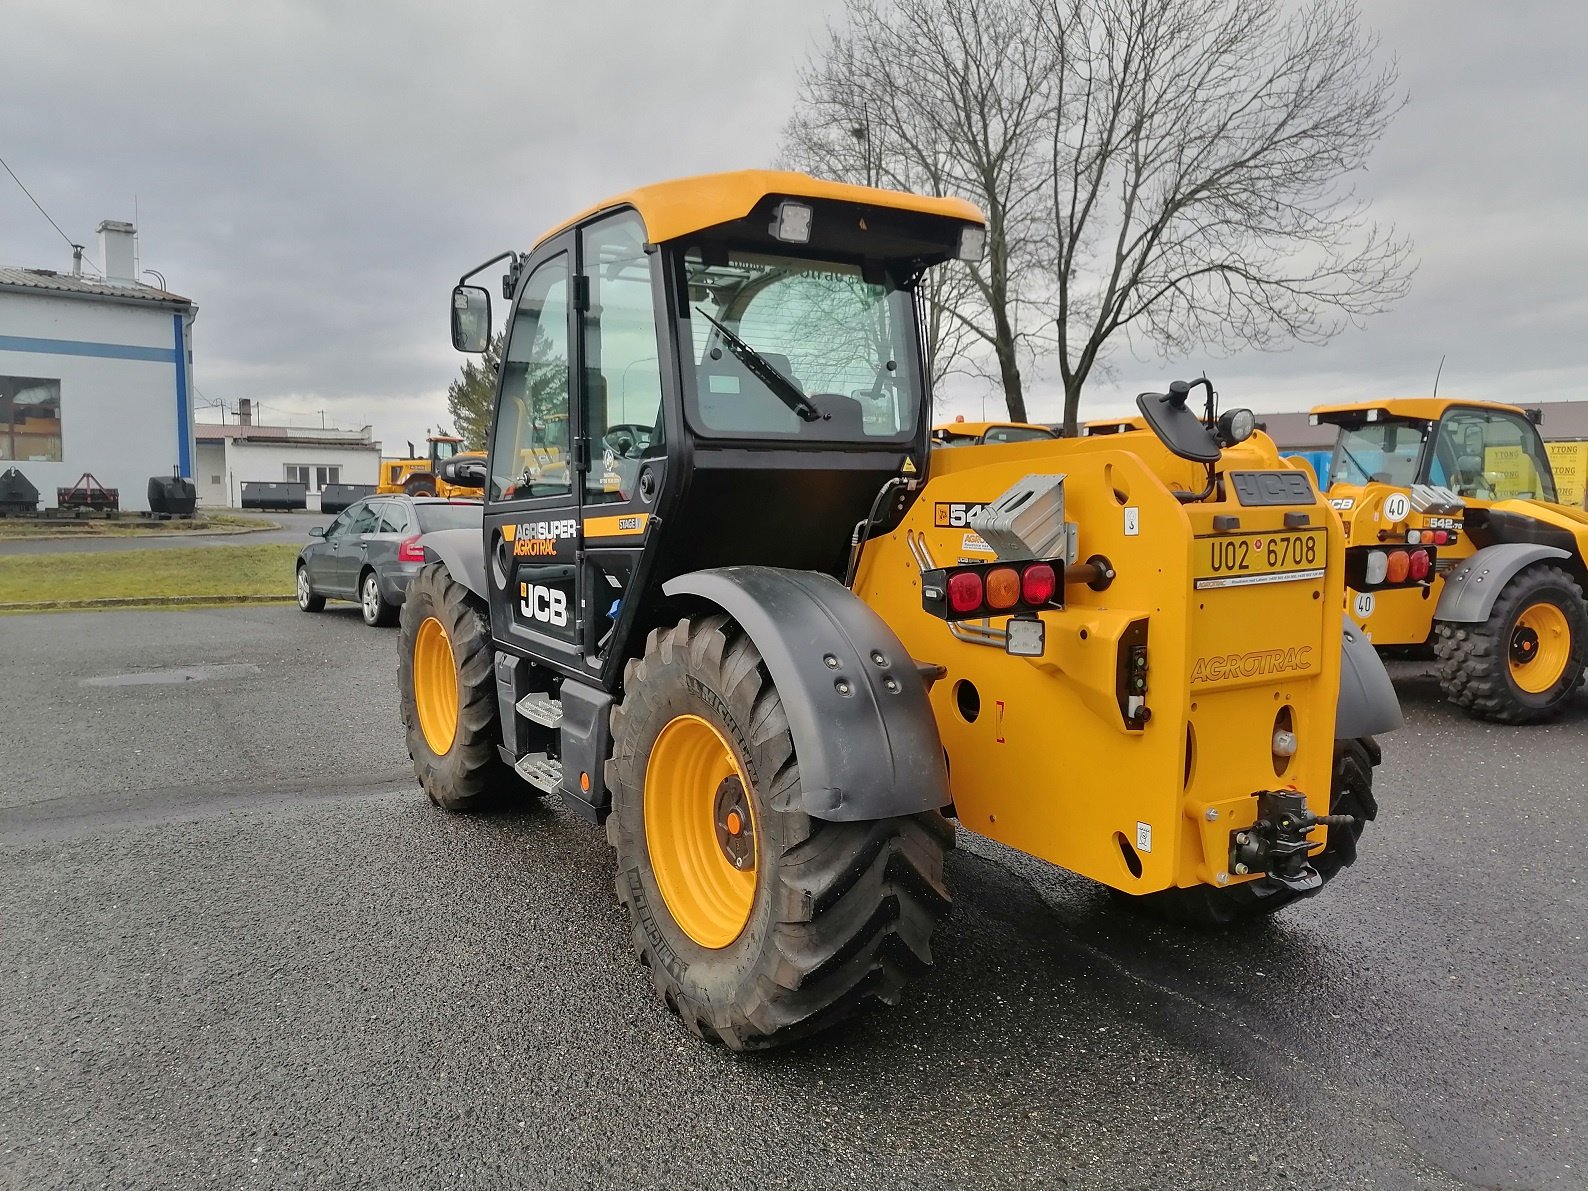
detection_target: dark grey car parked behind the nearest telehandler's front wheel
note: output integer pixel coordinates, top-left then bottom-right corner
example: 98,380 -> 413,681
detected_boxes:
297,495 -> 483,626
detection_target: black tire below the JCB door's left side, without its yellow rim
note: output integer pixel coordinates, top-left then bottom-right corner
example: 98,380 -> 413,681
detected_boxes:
397,562 -> 529,811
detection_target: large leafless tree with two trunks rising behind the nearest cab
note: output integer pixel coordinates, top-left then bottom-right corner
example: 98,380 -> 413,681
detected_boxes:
784,0 -> 1412,434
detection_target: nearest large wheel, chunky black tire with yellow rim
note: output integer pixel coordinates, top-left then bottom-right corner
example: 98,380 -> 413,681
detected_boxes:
607,616 -> 953,1050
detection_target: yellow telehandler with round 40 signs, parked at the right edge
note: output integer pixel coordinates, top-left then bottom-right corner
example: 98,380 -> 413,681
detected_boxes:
1312,397 -> 1588,724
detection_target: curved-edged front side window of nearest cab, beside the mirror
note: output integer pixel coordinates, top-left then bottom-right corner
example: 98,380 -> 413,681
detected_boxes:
489,256 -> 573,500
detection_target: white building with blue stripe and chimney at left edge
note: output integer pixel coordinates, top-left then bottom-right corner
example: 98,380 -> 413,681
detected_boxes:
0,221 -> 199,510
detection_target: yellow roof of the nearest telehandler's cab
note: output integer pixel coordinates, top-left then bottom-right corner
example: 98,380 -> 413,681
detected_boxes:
535,170 -> 985,246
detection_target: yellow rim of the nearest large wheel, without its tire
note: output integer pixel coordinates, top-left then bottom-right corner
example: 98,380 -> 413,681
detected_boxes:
645,715 -> 759,950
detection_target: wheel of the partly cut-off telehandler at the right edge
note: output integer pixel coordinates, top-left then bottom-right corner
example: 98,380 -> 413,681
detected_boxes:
1434,565 -> 1588,724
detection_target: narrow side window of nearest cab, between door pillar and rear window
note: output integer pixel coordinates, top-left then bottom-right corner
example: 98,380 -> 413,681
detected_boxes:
583,211 -> 662,505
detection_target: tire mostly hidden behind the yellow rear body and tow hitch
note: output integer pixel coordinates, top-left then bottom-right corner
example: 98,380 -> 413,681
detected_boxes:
1131,737 -> 1383,929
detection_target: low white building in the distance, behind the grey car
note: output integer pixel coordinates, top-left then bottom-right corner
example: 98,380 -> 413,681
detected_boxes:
194,399 -> 381,508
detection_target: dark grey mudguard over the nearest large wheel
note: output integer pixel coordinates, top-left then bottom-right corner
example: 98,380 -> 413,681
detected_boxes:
662,567 -> 948,823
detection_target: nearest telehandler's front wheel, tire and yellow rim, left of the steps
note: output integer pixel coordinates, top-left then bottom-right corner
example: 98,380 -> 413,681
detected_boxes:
397,562 -> 526,810
